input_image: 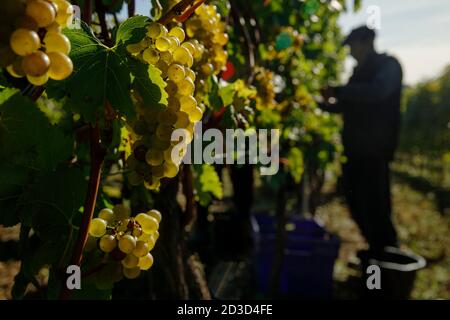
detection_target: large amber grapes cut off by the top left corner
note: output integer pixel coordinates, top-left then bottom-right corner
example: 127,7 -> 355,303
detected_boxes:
0,0 -> 73,86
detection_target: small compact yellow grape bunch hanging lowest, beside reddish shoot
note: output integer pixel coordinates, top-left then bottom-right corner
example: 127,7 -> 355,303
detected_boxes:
85,204 -> 161,282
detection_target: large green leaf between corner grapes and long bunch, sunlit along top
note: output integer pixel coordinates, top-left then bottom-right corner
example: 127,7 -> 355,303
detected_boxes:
49,23 -> 134,123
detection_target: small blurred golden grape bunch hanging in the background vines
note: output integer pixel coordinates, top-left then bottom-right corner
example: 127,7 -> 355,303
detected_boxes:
253,67 -> 276,110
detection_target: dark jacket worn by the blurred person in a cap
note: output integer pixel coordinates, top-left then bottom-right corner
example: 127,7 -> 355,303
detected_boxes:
324,53 -> 403,160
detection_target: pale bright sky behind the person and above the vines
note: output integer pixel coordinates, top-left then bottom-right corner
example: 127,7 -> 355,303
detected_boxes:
126,0 -> 450,84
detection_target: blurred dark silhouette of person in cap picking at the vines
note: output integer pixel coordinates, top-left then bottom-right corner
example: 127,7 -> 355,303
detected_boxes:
320,26 -> 403,257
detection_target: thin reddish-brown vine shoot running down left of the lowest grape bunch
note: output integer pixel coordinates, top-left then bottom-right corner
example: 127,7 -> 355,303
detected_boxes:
60,125 -> 105,300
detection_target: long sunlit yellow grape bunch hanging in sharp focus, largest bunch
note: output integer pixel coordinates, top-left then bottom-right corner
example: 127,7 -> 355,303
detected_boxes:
127,22 -> 204,190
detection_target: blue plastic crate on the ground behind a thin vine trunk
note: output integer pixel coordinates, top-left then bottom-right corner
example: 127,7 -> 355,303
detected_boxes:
254,215 -> 340,299
